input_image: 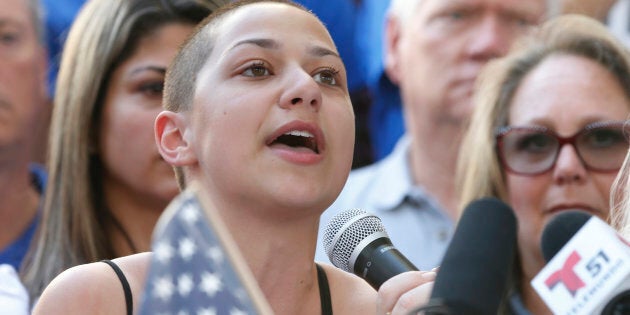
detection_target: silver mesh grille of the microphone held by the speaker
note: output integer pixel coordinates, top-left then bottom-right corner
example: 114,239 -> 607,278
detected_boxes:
323,209 -> 388,273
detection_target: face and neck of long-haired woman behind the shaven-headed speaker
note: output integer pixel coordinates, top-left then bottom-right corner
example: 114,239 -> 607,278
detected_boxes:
99,23 -> 193,256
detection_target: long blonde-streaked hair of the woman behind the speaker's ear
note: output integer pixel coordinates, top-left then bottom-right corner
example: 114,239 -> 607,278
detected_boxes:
22,0 -> 222,297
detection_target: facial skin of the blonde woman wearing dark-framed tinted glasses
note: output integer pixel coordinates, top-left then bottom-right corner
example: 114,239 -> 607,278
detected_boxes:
506,55 -> 630,314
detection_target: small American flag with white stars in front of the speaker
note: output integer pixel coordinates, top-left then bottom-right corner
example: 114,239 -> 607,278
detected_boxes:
140,185 -> 272,315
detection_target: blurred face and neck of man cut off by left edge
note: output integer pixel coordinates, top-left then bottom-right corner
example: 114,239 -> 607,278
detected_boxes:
0,0 -> 49,249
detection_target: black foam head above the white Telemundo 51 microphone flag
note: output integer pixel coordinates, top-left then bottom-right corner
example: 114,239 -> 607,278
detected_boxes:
540,210 -> 591,262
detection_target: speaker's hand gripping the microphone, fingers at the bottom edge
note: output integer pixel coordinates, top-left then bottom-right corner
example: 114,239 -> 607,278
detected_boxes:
377,269 -> 436,315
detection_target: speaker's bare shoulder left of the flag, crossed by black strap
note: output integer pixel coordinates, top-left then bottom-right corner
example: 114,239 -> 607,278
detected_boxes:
33,253 -> 150,315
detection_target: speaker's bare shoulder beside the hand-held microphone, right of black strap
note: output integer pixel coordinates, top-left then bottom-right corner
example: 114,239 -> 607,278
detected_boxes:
318,262 -> 377,314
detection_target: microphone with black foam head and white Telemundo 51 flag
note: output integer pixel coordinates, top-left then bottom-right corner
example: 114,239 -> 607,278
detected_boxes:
531,211 -> 630,315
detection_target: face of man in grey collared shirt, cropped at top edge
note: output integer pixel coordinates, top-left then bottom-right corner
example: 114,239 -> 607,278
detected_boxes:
386,0 -> 546,131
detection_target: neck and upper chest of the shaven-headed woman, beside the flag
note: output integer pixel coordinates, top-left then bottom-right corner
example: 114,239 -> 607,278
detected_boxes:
222,204 -> 321,314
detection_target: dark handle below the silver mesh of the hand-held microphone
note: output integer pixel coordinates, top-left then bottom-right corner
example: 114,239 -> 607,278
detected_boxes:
354,237 -> 418,290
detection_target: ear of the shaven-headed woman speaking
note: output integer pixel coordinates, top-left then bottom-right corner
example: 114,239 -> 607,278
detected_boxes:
155,111 -> 197,166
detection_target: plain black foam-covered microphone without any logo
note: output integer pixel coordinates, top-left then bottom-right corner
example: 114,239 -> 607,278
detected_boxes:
416,198 -> 517,315
